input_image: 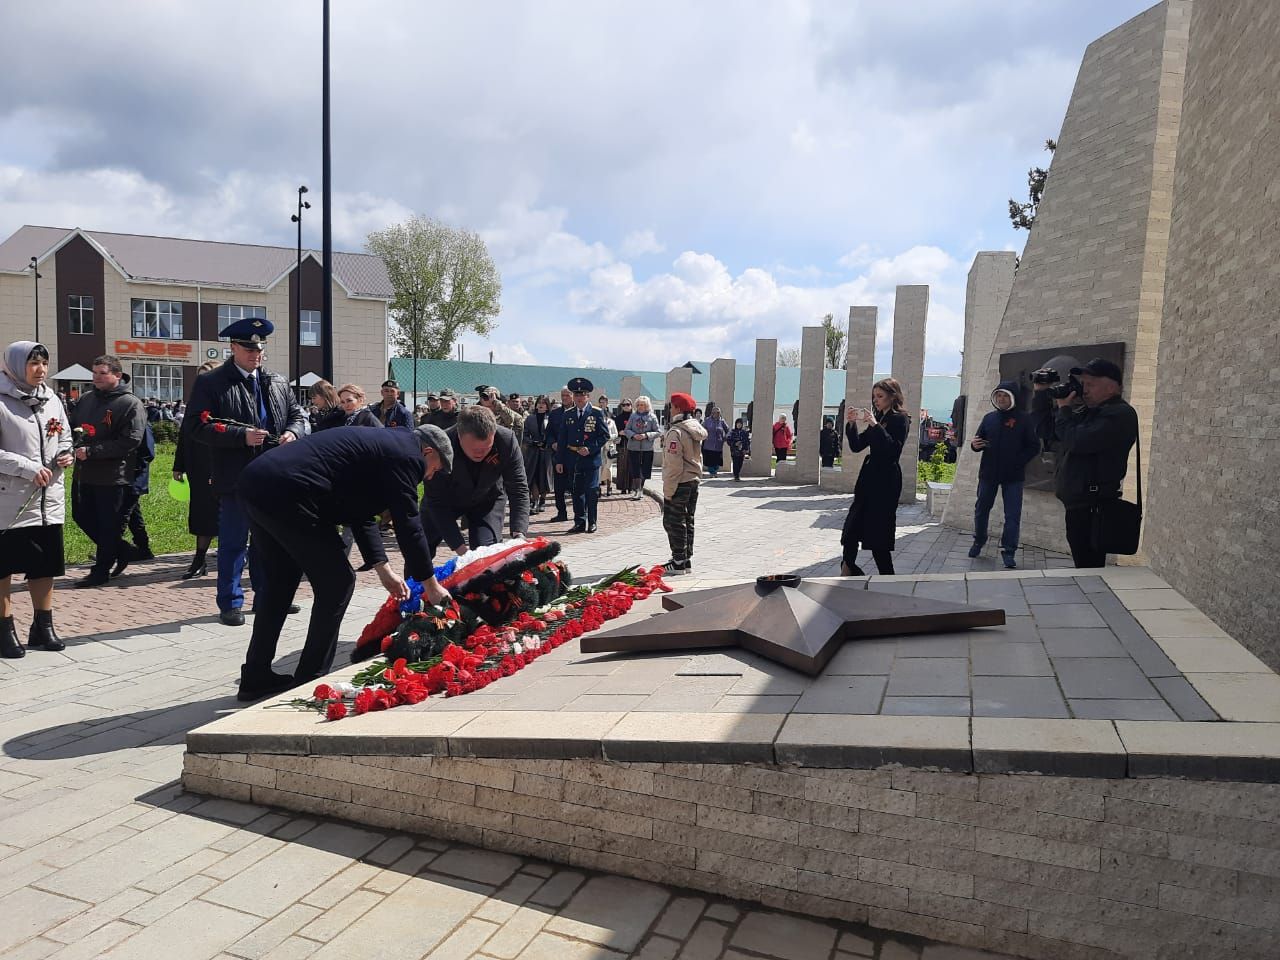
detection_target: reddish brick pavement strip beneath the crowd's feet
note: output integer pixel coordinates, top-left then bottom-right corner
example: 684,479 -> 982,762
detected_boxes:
5,495 -> 662,640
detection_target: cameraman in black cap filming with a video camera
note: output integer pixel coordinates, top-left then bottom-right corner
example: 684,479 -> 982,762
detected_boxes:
1032,357 -> 1138,567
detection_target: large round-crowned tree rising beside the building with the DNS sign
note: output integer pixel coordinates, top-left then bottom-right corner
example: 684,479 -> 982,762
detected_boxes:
365,216 -> 502,360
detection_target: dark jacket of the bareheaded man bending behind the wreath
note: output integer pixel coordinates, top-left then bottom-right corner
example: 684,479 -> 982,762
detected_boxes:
422,426 -> 529,550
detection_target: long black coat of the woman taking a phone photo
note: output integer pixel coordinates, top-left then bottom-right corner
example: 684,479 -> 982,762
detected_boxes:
840,413 -> 915,550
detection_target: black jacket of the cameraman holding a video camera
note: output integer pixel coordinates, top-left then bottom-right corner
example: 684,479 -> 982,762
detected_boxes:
1036,392 -> 1138,508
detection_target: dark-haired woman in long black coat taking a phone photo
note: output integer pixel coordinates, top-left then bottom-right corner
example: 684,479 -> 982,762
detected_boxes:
840,378 -> 915,576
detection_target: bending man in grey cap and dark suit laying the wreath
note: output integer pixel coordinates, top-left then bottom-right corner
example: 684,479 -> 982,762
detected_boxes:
236,426 -> 453,700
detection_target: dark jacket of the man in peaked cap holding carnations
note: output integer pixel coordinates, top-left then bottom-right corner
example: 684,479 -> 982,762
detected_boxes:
184,360 -> 306,497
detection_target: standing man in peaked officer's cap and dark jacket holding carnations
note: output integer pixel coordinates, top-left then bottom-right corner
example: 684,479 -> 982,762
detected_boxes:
186,317 -> 306,627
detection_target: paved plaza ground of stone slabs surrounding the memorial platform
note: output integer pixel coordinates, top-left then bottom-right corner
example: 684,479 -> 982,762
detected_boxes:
0,481 -> 1029,960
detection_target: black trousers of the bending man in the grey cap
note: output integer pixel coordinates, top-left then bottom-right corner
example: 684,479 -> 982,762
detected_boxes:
242,502 -> 356,684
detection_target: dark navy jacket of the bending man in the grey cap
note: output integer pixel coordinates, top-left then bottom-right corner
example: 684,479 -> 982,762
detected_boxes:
236,430 -> 433,580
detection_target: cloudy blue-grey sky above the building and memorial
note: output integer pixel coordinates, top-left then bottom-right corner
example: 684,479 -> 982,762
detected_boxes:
0,0 -> 1151,374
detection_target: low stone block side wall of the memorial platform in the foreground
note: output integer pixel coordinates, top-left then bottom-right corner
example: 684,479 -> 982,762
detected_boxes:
183,753 -> 1280,960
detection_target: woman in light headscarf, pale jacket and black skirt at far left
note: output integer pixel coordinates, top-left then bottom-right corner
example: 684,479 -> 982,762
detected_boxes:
0,340 -> 73,659
